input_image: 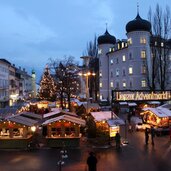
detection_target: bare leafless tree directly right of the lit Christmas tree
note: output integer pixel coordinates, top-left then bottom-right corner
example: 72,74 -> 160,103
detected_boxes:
50,56 -> 80,111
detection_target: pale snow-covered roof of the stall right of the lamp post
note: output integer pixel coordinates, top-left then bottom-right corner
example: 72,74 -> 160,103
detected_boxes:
91,111 -> 118,121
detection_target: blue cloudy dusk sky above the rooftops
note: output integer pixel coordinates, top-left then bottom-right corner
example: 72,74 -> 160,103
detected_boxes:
0,0 -> 171,79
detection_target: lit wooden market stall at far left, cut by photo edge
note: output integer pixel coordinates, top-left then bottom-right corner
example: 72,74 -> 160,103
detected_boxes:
0,112 -> 41,148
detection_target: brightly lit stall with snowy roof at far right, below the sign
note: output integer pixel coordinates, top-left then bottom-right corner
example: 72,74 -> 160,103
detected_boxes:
141,107 -> 171,128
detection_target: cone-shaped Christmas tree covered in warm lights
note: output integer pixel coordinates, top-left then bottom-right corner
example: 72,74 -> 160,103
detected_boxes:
39,66 -> 56,101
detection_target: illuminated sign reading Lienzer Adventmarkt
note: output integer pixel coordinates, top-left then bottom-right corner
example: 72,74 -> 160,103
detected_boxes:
114,91 -> 171,101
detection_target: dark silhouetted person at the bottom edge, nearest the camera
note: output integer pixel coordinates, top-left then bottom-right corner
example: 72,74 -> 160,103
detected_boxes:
87,151 -> 97,171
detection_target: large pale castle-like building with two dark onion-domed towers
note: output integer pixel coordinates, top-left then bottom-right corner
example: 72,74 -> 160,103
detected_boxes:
98,14 -> 171,101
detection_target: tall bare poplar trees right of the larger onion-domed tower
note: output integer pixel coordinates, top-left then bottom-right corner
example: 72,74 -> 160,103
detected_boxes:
147,4 -> 171,90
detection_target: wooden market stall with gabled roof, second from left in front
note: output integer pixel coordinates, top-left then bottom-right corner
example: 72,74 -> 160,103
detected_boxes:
42,109 -> 85,147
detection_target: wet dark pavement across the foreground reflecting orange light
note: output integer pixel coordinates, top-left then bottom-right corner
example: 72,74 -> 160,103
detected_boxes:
0,127 -> 171,171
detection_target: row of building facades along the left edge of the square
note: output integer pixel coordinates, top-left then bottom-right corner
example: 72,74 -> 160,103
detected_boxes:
0,59 -> 36,108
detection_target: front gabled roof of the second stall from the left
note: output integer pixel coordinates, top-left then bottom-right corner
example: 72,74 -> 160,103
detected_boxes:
42,115 -> 85,126
